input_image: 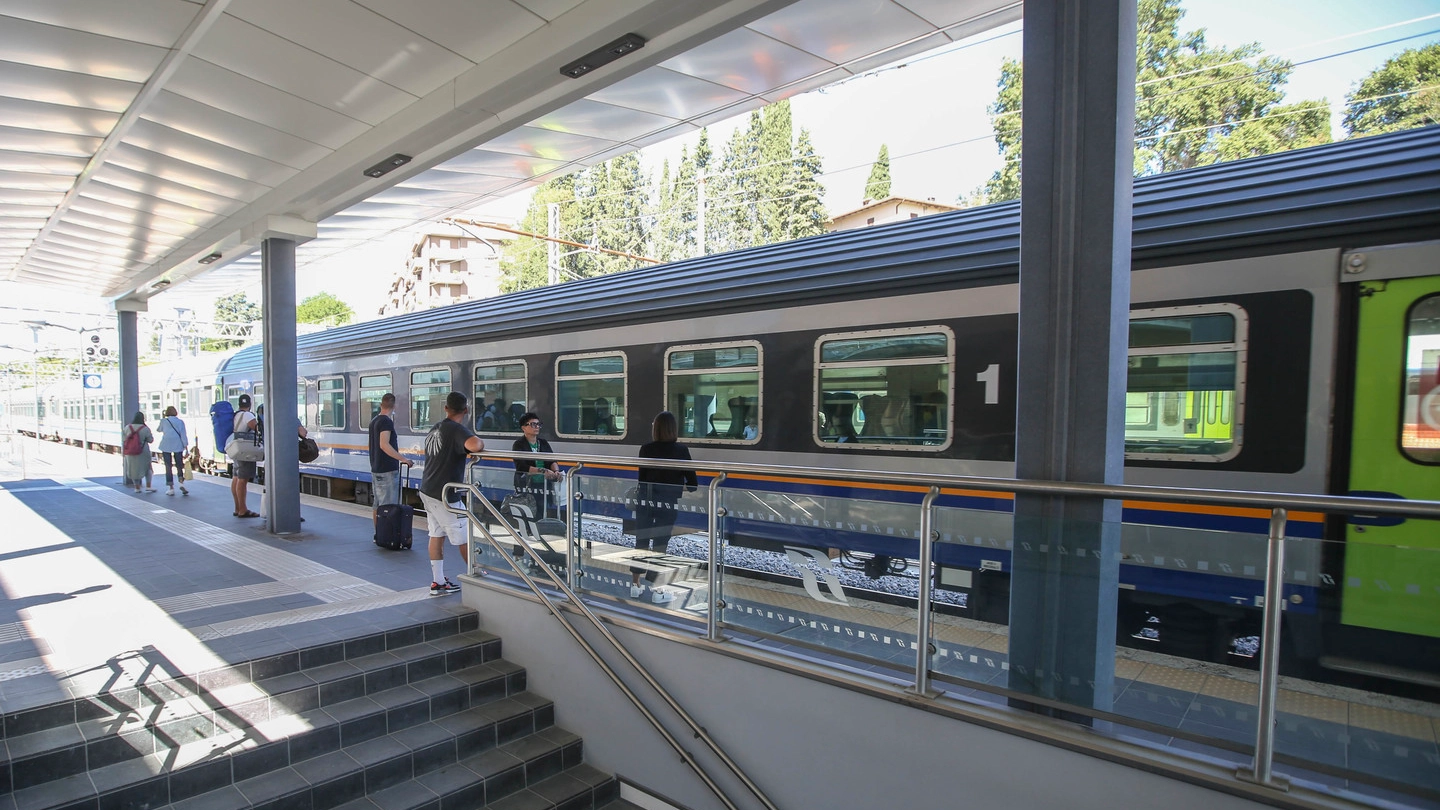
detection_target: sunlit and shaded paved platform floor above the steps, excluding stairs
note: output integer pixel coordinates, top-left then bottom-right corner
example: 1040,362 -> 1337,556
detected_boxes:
0,458 -> 469,713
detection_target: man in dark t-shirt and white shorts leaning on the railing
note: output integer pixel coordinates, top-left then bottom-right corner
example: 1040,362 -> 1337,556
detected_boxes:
420,391 -> 485,597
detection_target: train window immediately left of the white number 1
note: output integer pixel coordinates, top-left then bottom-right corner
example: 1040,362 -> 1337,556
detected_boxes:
814,327 -> 955,451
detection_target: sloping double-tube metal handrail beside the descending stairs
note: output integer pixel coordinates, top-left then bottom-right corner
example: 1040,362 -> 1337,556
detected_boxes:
441,483 -> 779,810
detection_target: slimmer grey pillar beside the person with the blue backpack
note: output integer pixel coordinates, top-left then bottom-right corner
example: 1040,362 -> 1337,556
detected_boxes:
261,236 -> 300,535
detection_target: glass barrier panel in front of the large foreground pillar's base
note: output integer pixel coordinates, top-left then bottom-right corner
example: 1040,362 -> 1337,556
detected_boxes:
930,493 -> 1269,765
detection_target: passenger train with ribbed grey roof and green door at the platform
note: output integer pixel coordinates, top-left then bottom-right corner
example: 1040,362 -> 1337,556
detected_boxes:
11,127 -> 1440,685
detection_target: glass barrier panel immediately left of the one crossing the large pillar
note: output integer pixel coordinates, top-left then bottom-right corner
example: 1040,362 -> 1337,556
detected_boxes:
720,479 -> 920,672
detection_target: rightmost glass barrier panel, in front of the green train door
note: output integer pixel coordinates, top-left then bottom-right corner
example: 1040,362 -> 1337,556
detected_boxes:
1274,530 -> 1440,800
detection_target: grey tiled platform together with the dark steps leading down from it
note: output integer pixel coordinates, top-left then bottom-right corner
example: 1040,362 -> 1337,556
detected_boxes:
0,447 -> 634,810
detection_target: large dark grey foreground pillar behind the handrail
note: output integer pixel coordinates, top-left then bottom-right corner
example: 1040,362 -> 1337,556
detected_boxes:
1009,0 -> 1136,711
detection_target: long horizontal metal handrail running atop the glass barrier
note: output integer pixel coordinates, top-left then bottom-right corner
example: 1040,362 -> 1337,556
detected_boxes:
477,450 -> 1440,520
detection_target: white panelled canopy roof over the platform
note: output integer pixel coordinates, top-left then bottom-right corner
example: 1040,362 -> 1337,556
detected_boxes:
0,0 -> 1020,306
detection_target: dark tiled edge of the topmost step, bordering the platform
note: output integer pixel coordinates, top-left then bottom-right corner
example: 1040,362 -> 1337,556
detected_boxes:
0,613 -> 486,739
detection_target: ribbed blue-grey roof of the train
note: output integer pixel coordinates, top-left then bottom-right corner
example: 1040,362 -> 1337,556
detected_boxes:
233,125 -> 1440,369
